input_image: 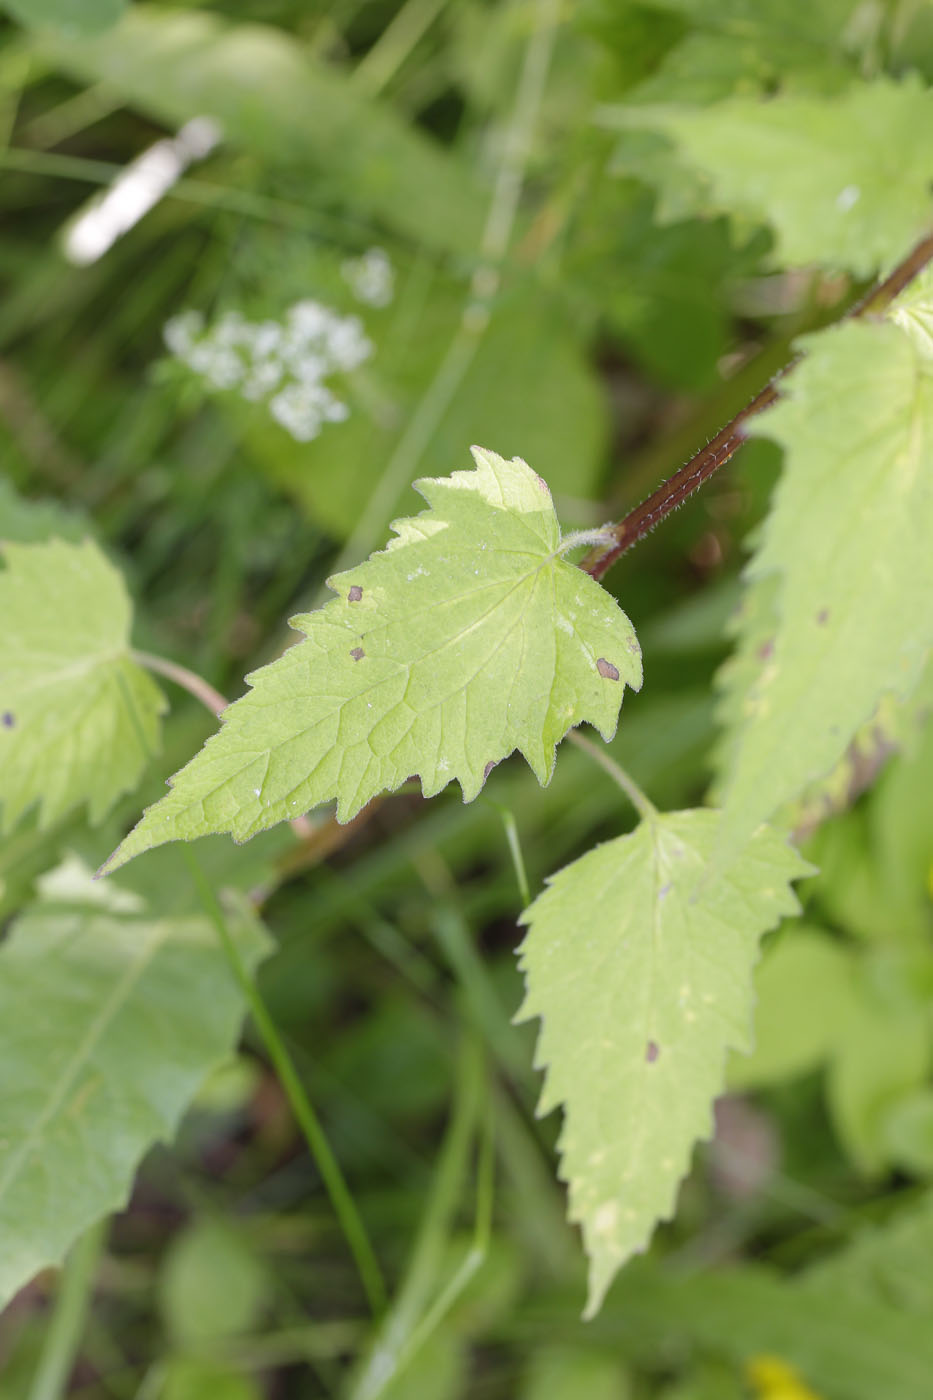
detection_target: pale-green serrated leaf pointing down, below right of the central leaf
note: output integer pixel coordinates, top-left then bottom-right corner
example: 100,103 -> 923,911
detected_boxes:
518,811 -> 810,1317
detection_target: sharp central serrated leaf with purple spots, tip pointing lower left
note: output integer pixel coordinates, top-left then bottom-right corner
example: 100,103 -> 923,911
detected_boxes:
105,448 -> 642,871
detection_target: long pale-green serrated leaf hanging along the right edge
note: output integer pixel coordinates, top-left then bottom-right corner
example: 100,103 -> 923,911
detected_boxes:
711,273 -> 933,853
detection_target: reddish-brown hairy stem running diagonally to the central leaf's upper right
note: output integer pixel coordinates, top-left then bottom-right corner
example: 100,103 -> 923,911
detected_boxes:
580,234 -> 933,580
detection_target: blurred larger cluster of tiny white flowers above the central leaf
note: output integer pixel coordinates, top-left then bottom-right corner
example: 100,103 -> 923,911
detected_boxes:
163,301 -> 373,442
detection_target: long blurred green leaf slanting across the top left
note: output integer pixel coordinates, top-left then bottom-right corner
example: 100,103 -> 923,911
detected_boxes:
30,0 -> 483,255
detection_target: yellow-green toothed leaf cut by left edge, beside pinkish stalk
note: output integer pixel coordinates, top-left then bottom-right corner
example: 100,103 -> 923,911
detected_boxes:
0,539 -> 165,832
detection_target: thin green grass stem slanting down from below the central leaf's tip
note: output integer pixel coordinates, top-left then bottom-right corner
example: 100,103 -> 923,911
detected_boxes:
182,847 -> 385,1316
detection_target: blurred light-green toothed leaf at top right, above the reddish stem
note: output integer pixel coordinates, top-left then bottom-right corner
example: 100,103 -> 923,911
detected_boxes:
611,77 -> 933,277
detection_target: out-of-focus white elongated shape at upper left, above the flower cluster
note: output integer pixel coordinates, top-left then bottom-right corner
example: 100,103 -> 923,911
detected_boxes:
62,116 -> 221,267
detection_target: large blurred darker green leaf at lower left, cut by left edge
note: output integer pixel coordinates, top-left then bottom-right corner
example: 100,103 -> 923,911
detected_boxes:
0,862 -> 268,1306
